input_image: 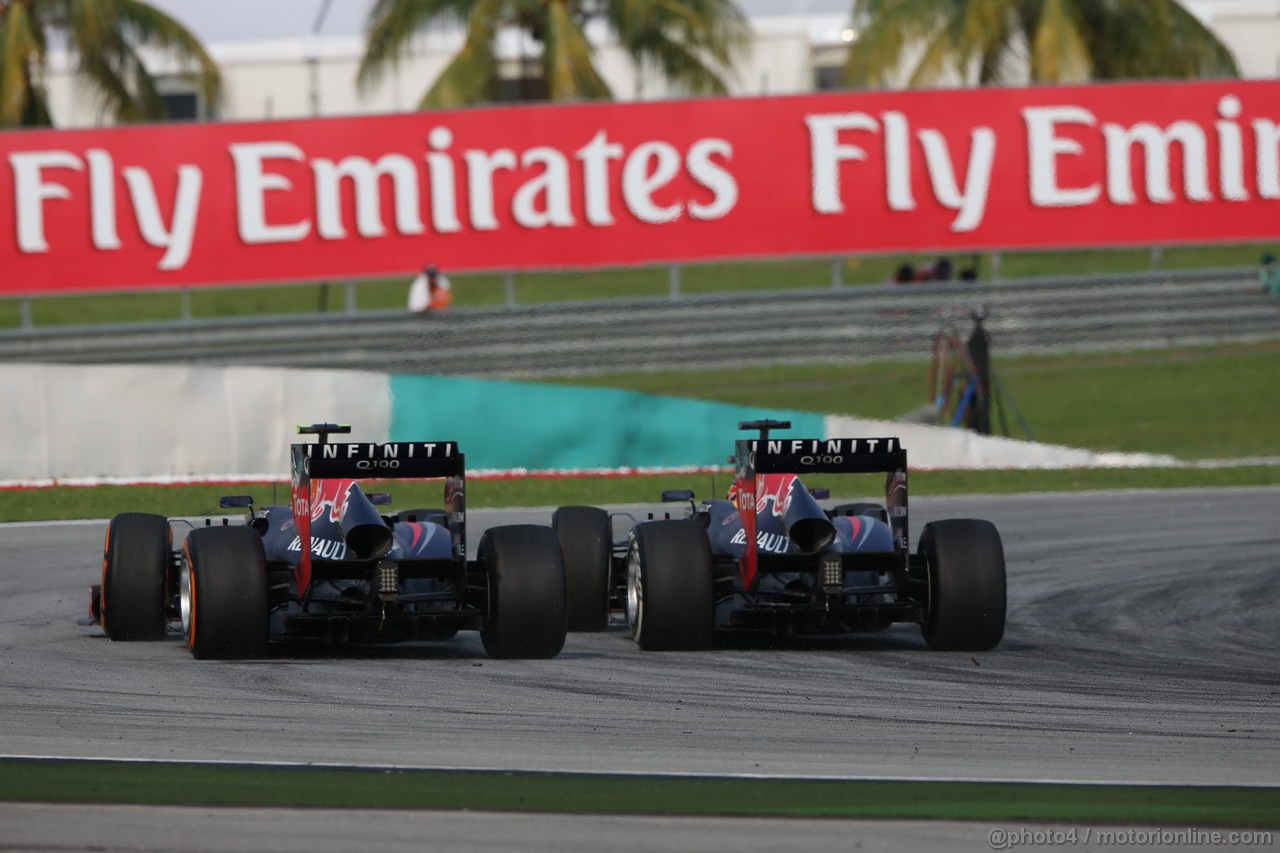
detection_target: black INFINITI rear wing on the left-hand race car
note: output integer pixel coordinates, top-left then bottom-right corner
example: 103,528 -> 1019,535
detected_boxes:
289,424 -> 466,592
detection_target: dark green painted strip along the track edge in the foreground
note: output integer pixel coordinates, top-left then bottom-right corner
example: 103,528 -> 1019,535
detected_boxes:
0,760 -> 1280,827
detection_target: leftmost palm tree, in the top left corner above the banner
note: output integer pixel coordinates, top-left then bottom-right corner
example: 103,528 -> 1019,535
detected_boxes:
0,0 -> 221,127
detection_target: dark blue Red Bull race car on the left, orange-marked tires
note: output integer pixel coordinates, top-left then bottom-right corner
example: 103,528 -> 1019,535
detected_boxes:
87,424 -> 566,658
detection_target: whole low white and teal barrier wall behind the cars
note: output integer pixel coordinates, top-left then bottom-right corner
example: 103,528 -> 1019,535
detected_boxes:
0,364 -> 1176,487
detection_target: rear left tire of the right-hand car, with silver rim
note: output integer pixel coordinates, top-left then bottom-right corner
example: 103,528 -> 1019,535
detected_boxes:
627,520 -> 716,652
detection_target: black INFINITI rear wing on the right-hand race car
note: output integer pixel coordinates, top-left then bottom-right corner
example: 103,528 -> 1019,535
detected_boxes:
733,420 -> 911,578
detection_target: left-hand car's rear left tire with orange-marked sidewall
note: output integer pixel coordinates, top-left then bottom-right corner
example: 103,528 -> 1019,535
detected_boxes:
179,528 -> 269,660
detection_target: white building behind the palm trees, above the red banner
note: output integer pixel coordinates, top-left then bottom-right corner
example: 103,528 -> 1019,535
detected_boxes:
37,0 -> 1280,128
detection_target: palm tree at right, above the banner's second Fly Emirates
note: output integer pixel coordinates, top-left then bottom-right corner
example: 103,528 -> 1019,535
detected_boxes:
845,0 -> 1239,86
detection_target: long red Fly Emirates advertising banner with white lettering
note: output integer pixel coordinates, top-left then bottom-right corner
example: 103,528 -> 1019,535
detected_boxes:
0,81 -> 1280,295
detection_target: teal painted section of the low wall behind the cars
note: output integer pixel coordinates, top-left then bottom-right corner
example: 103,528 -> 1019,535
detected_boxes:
390,375 -> 826,470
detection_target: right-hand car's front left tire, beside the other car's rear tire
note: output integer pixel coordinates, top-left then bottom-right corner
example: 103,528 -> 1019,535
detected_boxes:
552,506 -> 613,631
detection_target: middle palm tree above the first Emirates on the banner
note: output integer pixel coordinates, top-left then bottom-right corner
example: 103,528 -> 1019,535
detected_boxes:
357,0 -> 750,108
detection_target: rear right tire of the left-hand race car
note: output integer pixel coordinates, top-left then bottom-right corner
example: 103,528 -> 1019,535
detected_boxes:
479,524 -> 566,658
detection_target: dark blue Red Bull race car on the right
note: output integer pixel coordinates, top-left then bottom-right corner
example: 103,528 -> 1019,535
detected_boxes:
553,420 -> 1006,651
